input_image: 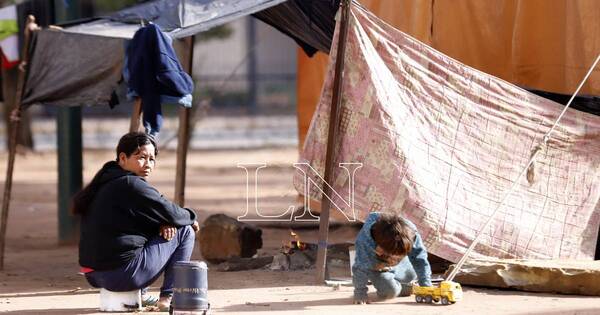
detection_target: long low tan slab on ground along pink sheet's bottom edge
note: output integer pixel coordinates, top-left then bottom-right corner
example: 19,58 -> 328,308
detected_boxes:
448,259 -> 600,296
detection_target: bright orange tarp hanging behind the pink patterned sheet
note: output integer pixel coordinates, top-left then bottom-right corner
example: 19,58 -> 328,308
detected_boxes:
297,0 -> 600,148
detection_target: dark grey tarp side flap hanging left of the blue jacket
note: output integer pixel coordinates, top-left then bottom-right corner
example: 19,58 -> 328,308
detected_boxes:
22,29 -> 124,106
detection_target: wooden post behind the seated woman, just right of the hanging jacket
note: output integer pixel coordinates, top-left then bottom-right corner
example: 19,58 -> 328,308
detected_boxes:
174,36 -> 194,207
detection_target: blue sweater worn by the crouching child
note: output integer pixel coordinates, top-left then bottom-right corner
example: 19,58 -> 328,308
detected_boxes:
353,212 -> 431,286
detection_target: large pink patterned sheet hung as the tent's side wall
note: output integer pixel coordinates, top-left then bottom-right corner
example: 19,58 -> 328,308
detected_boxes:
294,5 -> 600,261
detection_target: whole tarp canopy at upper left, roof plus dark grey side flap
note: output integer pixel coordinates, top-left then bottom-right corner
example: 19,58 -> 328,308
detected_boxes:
22,0 -> 339,106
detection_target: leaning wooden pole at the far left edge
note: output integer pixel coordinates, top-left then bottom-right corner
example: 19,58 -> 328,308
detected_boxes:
0,15 -> 38,270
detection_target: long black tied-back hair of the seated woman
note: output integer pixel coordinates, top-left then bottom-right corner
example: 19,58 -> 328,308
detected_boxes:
71,132 -> 158,214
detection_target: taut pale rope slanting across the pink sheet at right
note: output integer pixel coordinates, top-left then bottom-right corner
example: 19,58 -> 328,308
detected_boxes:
446,55 -> 600,281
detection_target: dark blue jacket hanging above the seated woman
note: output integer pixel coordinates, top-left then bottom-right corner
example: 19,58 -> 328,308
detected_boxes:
123,24 -> 194,136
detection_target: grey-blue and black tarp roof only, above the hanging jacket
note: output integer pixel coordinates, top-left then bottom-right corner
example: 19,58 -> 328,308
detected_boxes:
65,0 -> 340,56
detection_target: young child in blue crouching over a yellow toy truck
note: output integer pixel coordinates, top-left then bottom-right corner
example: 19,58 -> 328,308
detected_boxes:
352,212 -> 431,304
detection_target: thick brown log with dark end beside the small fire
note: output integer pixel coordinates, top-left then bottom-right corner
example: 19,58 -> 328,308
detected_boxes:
198,214 -> 262,264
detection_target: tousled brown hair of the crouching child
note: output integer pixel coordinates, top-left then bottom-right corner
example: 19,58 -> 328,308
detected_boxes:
371,213 -> 415,256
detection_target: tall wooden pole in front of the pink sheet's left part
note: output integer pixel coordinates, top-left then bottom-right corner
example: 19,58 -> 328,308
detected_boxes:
316,0 -> 350,284
